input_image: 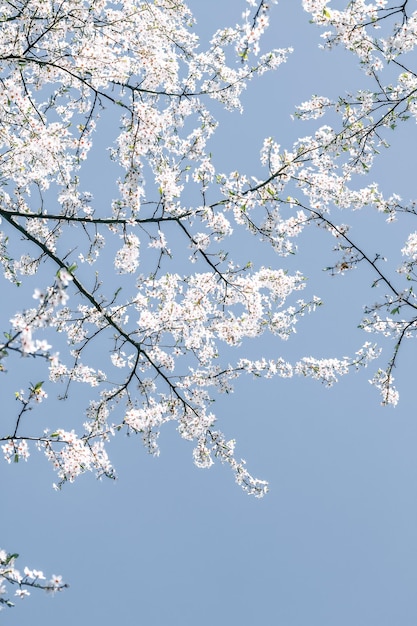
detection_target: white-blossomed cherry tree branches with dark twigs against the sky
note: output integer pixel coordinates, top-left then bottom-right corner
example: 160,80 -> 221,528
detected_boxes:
0,0 -> 417,605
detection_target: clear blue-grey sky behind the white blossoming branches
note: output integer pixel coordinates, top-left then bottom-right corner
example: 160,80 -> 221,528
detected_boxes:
0,0 -> 417,626
